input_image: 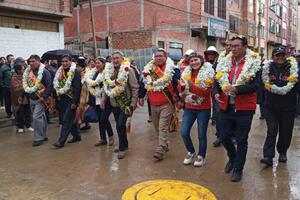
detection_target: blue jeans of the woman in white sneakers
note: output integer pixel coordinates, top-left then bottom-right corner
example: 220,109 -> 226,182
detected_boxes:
181,109 -> 211,158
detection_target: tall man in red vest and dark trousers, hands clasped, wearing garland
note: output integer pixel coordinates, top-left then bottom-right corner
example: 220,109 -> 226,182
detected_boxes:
215,36 -> 261,182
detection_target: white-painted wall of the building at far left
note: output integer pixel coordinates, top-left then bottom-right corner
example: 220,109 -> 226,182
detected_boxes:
0,22 -> 64,59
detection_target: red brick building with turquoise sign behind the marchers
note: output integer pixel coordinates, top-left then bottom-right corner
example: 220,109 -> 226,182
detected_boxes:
65,0 -> 231,56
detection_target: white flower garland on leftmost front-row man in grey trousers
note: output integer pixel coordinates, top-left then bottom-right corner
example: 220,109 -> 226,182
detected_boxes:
22,64 -> 45,94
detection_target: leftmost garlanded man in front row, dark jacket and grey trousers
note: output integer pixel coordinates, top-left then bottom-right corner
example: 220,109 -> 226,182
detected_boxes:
23,55 -> 52,147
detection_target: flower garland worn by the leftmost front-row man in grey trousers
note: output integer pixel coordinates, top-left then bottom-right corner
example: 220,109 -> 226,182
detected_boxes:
22,64 -> 45,94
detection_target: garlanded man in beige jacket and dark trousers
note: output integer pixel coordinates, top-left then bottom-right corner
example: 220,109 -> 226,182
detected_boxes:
100,51 -> 139,159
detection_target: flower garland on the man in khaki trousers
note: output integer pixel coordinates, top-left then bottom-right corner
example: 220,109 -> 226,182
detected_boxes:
142,58 -> 174,92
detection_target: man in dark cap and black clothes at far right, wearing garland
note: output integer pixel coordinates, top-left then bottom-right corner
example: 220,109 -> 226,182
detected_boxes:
261,47 -> 300,166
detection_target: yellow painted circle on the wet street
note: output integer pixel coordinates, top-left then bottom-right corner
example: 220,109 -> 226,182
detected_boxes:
122,180 -> 217,200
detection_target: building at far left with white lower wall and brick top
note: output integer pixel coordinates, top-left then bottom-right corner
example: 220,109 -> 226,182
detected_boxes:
0,0 -> 73,58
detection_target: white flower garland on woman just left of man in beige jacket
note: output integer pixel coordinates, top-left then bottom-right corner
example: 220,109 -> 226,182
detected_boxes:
85,68 -> 104,97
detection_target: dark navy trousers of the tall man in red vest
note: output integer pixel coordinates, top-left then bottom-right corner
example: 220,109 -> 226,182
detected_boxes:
220,107 -> 253,171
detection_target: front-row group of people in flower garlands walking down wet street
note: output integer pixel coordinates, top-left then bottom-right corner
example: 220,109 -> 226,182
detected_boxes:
4,36 -> 300,182
